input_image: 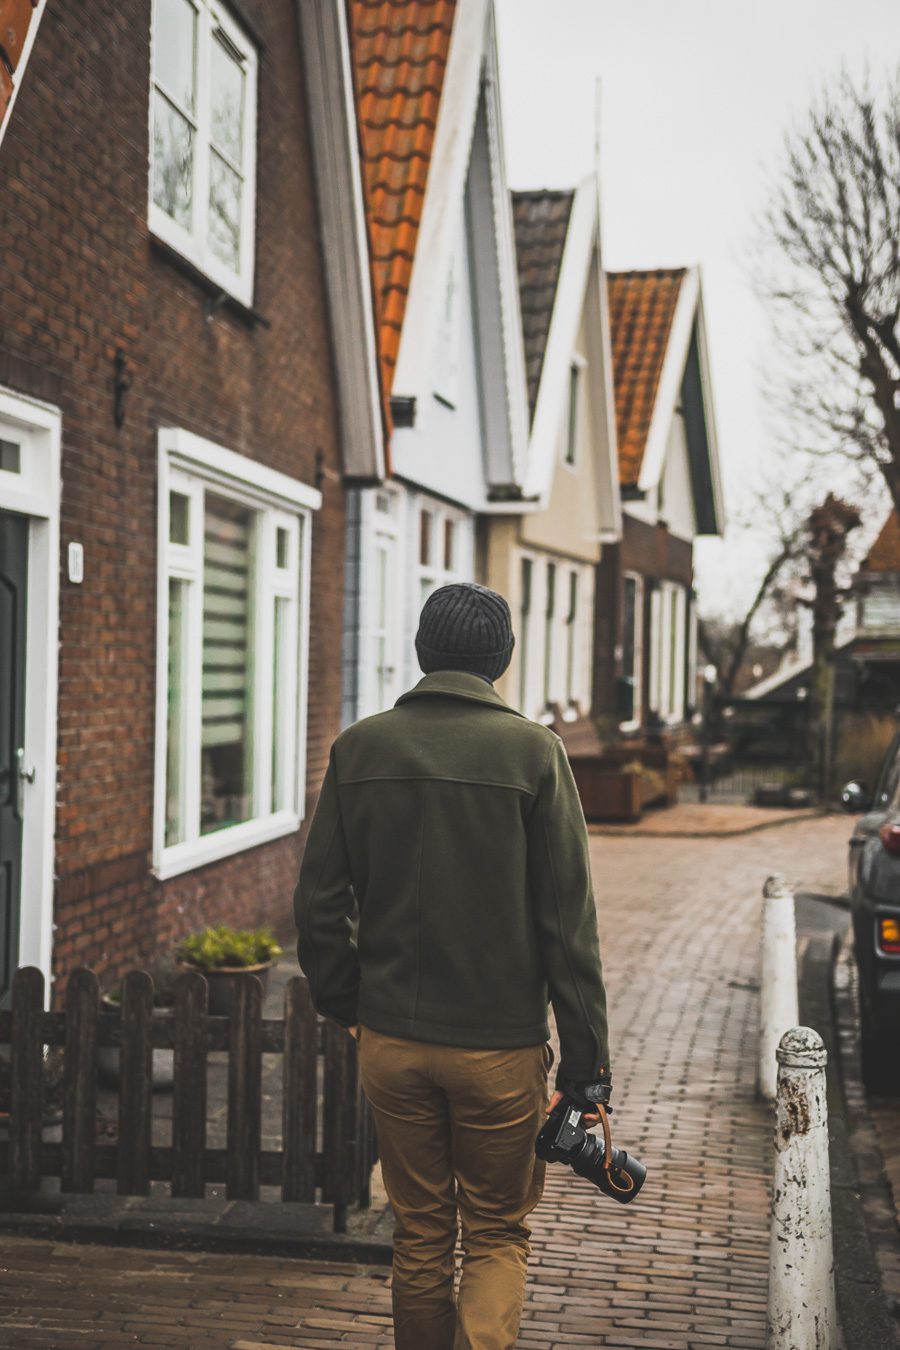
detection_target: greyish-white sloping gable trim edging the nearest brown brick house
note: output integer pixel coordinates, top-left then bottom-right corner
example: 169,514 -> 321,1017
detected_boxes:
297,0 -> 385,479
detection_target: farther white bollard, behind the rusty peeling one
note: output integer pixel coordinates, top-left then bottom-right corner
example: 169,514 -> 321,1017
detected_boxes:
757,873 -> 800,1102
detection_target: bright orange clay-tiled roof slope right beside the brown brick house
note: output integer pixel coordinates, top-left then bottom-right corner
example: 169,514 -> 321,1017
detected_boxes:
348,0 -> 456,398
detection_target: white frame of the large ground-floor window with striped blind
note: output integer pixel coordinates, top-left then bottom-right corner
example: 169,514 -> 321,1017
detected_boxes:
152,428 -> 321,880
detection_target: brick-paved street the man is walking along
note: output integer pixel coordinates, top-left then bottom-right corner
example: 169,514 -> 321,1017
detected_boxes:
0,817 -> 847,1350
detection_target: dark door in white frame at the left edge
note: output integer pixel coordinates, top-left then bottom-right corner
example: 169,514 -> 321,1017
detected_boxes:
0,510 -> 28,1007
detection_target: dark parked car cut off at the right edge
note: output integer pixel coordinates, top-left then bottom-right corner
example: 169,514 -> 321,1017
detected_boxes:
841,730 -> 900,1092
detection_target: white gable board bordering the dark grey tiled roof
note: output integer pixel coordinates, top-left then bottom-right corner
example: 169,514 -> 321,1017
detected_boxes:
525,177 -> 598,510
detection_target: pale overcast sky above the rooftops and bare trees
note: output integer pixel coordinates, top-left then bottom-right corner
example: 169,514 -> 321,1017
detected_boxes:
497,0 -> 900,612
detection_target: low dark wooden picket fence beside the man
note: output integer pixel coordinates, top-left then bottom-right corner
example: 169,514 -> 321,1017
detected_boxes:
0,967 -> 375,1231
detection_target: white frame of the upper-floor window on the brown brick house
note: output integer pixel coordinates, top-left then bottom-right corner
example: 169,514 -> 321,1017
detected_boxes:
147,0 -> 258,306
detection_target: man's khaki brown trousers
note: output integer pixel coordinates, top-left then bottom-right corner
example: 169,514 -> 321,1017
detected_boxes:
359,1027 -> 552,1350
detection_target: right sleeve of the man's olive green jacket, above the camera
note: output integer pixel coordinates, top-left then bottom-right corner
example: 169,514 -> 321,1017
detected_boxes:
528,737 -> 610,1081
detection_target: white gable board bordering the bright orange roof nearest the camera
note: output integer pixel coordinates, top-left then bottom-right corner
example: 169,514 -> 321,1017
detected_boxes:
391,0 -> 487,400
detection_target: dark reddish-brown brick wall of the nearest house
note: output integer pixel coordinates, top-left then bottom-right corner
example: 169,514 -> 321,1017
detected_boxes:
0,0 -> 344,1004
